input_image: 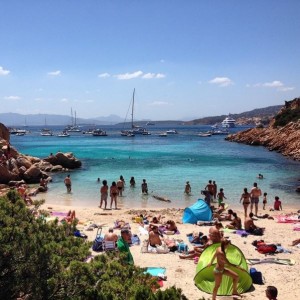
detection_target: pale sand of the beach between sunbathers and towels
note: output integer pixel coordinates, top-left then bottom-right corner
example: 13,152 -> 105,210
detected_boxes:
39,195 -> 300,300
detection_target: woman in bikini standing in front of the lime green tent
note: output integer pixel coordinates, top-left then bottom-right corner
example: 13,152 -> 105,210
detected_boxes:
208,238 -> 240,300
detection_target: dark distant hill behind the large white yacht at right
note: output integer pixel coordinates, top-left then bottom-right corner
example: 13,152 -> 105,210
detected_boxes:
184,105 -> 283,125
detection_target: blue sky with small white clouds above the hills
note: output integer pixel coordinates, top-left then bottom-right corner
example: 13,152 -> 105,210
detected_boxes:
0,0 -> 300,120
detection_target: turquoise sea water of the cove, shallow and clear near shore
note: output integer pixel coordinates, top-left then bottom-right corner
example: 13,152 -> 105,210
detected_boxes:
11,125 -> 300,208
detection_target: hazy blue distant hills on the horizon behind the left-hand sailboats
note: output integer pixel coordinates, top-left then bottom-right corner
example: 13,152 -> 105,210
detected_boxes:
0,113 -> 123,127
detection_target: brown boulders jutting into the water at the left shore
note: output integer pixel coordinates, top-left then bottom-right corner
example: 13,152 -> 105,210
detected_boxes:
0,123 -> 81,193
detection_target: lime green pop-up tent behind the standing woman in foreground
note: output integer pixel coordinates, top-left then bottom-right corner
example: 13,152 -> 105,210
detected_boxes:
194,243 -> 252,296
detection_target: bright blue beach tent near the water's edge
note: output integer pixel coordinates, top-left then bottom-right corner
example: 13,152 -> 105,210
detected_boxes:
182,199 -> 212,224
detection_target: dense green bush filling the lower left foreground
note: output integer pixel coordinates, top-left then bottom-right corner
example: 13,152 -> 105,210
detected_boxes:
0,190 -> 187,300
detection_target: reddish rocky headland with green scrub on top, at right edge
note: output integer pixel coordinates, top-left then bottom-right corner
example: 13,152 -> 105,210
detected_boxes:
226,98 -> 300,161
